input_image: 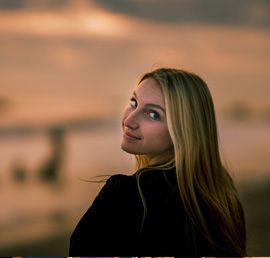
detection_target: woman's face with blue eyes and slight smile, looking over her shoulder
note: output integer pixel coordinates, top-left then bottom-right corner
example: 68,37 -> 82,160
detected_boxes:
121,78 -> 173,164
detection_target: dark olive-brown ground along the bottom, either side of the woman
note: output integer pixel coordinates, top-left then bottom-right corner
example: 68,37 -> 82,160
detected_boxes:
0,180 -> 270,257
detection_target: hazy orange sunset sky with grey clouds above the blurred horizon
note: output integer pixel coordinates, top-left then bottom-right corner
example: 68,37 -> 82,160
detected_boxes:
0,0 -> 270,127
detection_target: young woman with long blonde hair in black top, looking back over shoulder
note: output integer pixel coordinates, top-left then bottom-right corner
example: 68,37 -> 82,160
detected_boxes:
70,68 -> 246,257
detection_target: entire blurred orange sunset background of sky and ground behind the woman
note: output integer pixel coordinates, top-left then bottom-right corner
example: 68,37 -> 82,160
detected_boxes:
0,0 -> 270,256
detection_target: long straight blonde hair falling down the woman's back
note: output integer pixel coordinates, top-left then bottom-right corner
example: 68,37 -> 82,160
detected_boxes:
136,68 -> 246,257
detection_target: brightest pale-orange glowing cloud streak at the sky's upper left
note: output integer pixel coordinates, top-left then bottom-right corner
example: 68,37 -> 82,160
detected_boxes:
0,4 -> 127,37
